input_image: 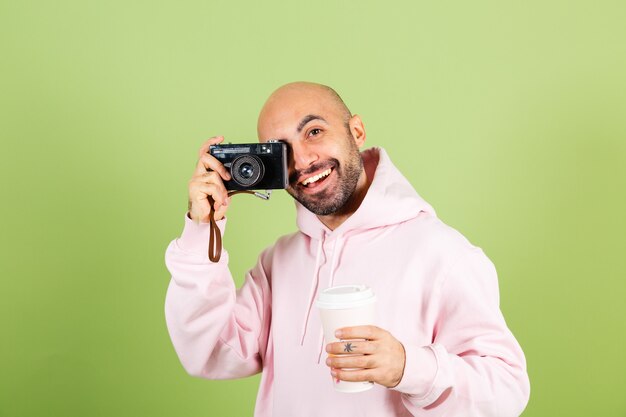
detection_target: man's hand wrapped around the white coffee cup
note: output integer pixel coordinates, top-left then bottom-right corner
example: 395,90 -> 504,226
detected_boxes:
326,326 -> 405,388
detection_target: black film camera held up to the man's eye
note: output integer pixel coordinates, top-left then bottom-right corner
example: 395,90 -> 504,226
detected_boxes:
209,140 -> 289,191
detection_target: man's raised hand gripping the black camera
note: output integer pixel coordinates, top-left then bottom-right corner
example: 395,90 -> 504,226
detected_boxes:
189,136 -> 230,223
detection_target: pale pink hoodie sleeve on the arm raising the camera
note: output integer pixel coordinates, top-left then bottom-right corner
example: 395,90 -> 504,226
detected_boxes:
165,216 -> 271,379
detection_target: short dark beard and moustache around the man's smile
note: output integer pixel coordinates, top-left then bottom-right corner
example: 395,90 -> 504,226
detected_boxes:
287,143 -> 363,216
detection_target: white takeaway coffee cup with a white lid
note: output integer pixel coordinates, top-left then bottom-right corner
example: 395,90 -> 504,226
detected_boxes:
315,284 -> 376,392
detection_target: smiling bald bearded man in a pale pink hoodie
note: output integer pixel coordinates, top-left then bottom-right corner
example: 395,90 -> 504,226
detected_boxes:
166,82 -> 529,417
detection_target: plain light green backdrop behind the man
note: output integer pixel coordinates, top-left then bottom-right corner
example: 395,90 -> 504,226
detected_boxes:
0,0 -> 626,417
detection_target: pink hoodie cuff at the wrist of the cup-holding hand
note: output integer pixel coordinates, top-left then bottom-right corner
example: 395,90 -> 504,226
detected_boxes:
392,343 -> 441,407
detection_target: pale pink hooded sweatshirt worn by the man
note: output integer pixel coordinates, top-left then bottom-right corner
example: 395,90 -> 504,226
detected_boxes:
165,148 -> 529,417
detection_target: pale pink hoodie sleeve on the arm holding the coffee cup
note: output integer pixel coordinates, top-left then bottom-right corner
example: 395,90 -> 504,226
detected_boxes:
394,247 -> 530,417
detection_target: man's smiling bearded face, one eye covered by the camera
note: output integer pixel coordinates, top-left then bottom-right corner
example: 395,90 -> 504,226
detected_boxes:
259,85 -> 363,216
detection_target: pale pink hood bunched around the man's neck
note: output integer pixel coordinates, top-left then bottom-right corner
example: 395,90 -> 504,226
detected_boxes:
296,147 -> 435,240
